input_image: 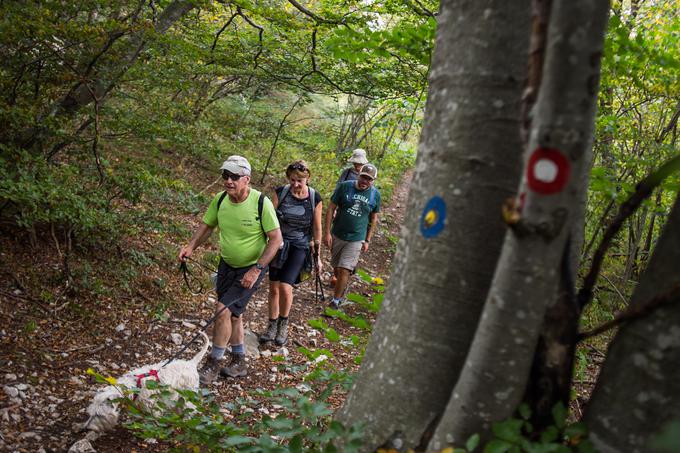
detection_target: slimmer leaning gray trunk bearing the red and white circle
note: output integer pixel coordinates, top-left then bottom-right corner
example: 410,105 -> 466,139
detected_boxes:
429,0 -> 609,444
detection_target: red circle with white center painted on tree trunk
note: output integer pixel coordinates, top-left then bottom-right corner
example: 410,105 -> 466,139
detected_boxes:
527,148 -> 571,195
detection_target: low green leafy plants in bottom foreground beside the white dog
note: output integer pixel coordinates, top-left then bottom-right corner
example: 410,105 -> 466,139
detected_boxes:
88,369 -> 362,453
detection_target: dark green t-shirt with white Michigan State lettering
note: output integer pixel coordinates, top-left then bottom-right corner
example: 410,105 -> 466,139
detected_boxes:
331,181 -> 380,242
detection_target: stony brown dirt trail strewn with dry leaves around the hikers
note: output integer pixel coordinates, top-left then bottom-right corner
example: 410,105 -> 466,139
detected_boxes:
0,172 -> 412,452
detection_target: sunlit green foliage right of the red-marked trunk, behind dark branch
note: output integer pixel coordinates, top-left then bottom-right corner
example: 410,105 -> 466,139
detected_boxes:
580,0 -> 680,328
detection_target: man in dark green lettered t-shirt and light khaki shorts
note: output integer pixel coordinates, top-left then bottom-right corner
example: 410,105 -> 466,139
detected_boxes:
324,164 -> 380,309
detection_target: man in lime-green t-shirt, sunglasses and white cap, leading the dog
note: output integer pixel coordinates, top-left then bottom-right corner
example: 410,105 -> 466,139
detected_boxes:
179,156 -> 283,385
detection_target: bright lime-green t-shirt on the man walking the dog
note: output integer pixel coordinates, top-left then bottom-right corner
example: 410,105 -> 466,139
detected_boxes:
203,189 -> 279,267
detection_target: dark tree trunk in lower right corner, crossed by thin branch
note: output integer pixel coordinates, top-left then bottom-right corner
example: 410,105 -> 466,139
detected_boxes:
584,198 -> 680,453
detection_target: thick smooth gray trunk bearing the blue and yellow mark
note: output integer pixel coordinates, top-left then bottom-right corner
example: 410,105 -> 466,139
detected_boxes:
338,0 -> 530,451
